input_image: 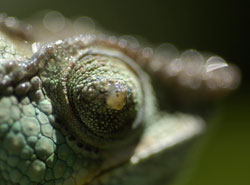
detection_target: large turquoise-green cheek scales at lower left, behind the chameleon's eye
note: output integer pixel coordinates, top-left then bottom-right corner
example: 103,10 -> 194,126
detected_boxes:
0,96 -> 97,185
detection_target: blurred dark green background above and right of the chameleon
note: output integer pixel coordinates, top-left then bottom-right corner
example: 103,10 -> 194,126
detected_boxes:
0,0 -> 250,185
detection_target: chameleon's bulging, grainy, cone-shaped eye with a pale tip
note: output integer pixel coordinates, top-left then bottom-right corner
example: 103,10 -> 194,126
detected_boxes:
38,35 -> 149,148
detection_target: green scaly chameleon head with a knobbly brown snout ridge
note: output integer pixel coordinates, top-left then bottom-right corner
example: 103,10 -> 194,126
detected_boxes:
0,11 -> 240,185
